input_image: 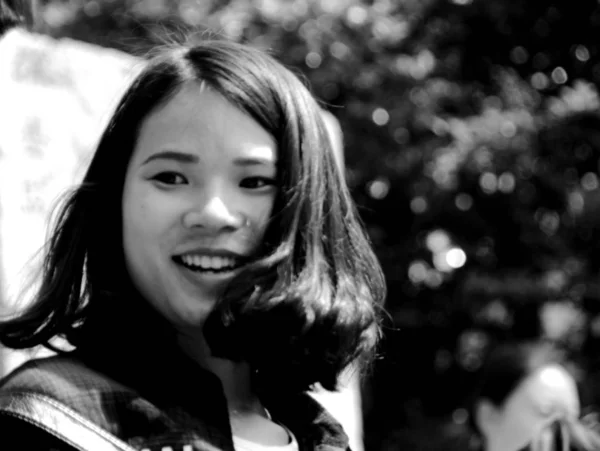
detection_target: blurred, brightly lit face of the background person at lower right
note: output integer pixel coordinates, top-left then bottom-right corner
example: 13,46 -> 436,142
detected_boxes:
483,365 -> 579,451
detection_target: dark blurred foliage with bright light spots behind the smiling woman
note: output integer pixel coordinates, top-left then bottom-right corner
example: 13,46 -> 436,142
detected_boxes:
31,0 -> 600,450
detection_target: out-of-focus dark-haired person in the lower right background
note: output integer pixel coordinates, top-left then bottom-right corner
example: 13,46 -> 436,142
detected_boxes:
470,342 -> 600,451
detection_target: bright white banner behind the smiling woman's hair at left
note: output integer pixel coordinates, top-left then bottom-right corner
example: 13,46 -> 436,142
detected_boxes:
0,29 -> 139,373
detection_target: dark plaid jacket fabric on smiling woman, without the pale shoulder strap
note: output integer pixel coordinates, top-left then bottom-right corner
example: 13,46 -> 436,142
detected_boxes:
0,356 -> 348,451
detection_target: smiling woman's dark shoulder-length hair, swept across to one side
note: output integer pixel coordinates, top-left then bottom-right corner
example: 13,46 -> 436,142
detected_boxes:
0,40 -> 385,390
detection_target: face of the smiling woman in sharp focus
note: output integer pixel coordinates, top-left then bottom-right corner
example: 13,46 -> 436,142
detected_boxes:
122,83 -> 277,328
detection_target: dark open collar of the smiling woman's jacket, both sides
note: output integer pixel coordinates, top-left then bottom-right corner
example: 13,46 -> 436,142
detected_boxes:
79,341 -> 348,451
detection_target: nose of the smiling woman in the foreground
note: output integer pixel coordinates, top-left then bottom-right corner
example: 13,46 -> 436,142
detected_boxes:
183,196 -> 245,231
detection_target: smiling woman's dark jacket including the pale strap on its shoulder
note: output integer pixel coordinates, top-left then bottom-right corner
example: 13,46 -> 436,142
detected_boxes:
0,353 -> 348,451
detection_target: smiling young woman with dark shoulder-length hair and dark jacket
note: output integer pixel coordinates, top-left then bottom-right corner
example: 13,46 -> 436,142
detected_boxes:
0,41 -> 384,451
